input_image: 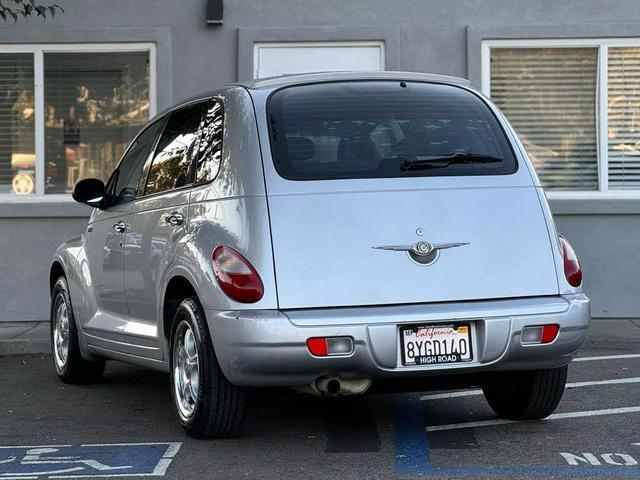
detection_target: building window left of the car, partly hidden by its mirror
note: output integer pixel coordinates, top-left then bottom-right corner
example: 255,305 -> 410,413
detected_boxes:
0,44 -> 155,194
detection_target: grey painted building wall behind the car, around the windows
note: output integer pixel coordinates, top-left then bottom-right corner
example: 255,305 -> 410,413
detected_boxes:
0,0 -> 640,321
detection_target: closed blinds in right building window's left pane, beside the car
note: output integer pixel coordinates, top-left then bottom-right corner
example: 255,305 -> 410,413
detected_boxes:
491,48 -> 598,190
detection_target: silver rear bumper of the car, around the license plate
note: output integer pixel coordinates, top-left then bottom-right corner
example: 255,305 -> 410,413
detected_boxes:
206,294 -> 590,386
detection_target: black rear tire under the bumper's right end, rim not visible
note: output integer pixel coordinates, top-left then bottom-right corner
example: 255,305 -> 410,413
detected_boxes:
482,366 -> 568,420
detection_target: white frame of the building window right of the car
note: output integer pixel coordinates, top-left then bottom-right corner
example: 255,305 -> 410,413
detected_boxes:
480,37 -> 640,200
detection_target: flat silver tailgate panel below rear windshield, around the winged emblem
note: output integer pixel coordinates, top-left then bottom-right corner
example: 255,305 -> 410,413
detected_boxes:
268,186 -> 558,309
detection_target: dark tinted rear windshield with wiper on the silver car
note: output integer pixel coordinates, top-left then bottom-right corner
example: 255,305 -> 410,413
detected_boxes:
267,81 -> 517,180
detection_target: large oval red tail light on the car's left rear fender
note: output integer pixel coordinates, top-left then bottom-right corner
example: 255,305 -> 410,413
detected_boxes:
211,245 -> 264,303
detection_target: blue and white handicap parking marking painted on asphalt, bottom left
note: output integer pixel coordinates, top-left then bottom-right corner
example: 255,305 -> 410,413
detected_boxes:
0,442 -> 182,480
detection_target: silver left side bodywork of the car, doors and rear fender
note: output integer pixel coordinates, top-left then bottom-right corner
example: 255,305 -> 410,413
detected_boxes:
51,87 -> 277,371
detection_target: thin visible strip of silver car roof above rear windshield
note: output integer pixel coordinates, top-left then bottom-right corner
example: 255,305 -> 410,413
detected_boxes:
231,71 -> 471,89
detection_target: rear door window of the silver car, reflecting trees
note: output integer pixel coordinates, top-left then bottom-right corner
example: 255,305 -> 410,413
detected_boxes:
144,102 -> 207,195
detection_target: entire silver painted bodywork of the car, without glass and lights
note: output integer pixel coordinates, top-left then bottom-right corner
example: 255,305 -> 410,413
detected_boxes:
55,72 -> 589,386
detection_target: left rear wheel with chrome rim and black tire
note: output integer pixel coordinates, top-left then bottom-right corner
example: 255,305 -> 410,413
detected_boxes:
170,297 -> 245,438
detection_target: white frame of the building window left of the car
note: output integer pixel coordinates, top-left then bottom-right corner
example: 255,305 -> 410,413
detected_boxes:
0,42 -> 157,202
